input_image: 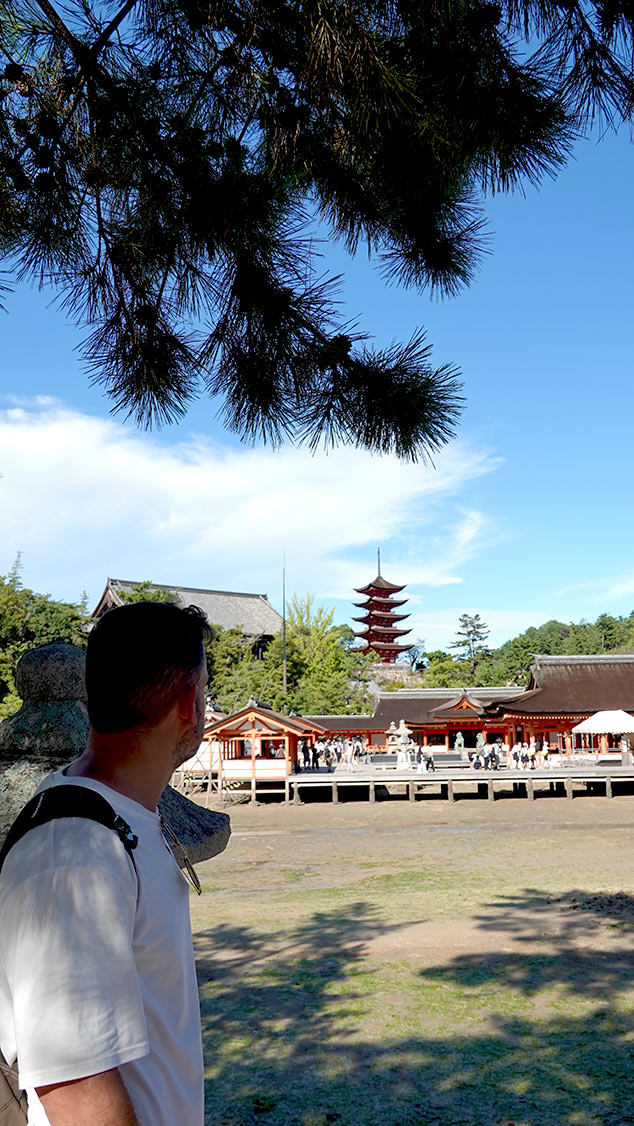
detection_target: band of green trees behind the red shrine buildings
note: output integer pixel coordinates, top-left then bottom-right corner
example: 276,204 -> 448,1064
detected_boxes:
0,558 -> 634,720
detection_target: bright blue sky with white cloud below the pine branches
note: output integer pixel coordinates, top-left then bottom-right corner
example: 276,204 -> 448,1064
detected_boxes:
0,131 -> 634,649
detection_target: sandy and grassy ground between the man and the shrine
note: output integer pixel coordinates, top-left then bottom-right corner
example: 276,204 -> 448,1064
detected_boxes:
193,797 -> 634,1126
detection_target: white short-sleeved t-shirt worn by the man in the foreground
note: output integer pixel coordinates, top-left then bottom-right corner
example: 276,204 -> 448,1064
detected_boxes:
0,771 -> 204,1126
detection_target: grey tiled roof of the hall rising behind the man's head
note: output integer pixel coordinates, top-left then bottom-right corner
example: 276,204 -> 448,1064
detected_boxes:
108,579 -> 282,637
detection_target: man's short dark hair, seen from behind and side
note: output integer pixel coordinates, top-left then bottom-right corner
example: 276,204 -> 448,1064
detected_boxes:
86,601 -> 209,734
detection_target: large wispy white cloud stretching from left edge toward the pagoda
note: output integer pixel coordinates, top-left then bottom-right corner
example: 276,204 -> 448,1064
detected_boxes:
0,400 -> 499,604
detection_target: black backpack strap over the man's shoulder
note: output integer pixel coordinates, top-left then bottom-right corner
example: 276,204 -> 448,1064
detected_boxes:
0,785 -> 139,872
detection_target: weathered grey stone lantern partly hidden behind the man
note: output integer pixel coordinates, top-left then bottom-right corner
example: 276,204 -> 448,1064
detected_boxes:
0,642 -> 231,864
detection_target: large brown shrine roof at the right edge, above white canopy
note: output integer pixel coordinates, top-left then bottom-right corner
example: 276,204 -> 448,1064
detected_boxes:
488,653 -> 634,715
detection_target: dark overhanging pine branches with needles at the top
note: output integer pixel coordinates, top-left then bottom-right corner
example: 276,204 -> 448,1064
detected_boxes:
0,0 -> 633,457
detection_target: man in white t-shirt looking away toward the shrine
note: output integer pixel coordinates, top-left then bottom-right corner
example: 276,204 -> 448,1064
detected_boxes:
0,602 -> 207,1126
